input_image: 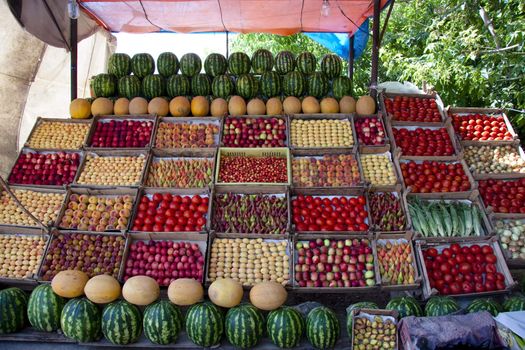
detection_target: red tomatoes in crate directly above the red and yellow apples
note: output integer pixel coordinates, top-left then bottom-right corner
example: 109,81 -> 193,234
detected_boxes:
292,194 -> 369,232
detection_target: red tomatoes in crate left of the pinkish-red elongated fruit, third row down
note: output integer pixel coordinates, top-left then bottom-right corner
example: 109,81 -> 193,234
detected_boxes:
132,192 -> 209,232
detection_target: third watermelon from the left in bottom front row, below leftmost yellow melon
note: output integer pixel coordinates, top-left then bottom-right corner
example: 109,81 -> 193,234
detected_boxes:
60,298 -> 102,343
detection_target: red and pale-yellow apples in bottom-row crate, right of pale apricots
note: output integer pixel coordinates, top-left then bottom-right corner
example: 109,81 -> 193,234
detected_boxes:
295,238 -> 376,288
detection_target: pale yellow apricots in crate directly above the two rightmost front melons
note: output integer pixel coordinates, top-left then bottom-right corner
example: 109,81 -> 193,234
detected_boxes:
208,238 -> 290,286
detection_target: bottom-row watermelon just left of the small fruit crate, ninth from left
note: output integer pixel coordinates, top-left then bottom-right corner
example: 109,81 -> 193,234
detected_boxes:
306,306 -> 341,349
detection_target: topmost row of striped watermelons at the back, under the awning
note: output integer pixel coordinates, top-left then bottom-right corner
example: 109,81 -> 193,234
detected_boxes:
108,49 -> 343,79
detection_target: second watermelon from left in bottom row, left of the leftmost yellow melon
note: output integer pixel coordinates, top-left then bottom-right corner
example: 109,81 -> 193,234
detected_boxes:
27,284 -> 66,332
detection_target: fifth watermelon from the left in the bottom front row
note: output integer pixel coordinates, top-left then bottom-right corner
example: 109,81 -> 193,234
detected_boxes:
143,300 -> 183,345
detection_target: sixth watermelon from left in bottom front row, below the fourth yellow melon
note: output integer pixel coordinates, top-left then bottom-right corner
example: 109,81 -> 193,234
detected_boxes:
186,301 -> 224,347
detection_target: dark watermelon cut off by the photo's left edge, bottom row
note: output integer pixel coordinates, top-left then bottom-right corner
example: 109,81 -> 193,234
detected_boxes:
0,288 -> 27,334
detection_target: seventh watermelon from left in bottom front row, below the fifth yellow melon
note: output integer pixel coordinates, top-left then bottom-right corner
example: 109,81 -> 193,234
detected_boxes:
224,304 -> 264,349
